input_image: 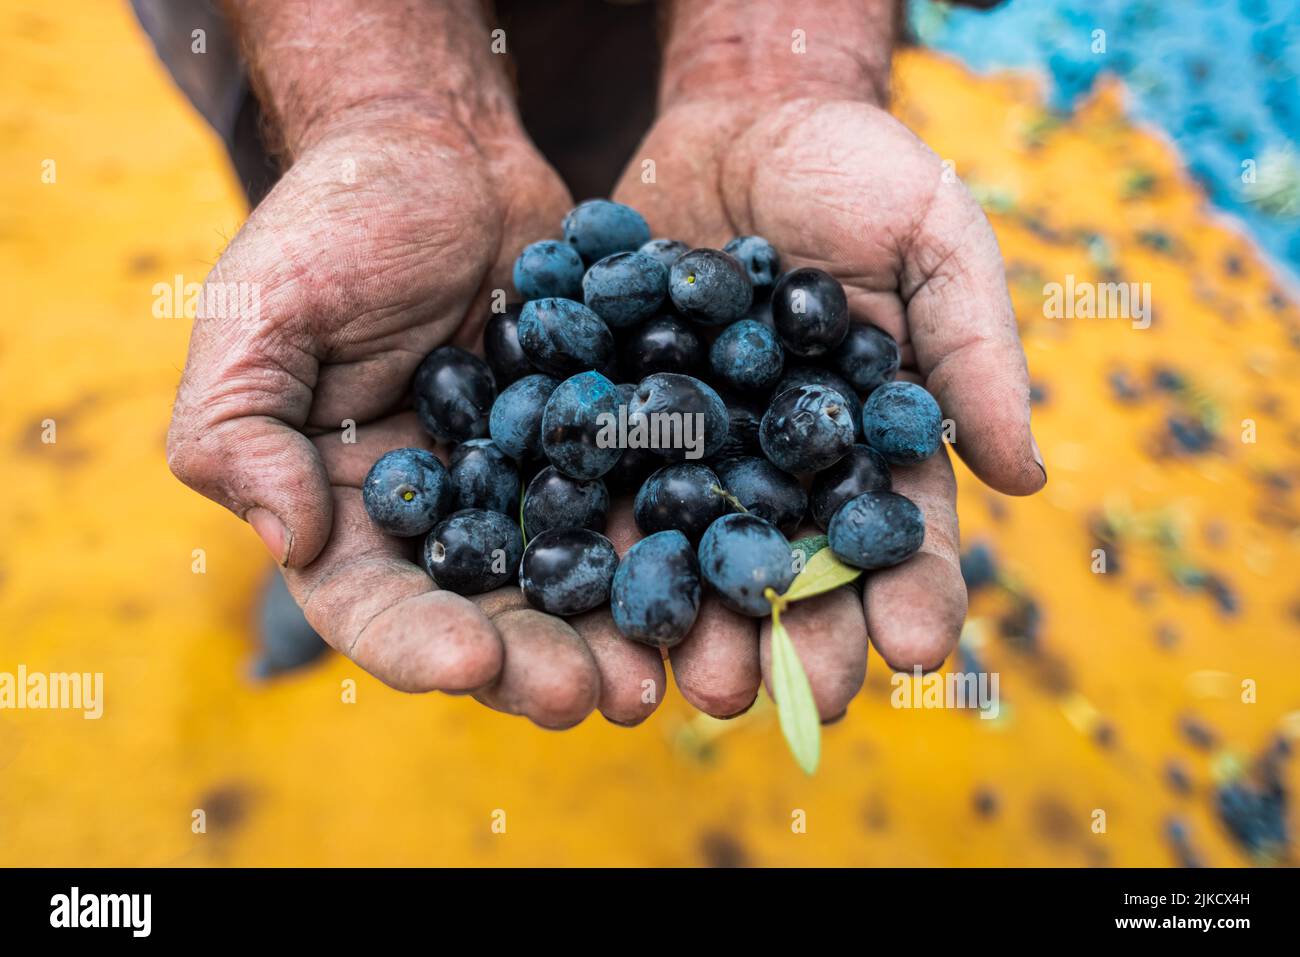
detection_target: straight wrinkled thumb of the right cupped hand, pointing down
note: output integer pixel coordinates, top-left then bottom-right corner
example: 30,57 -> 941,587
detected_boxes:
902,183 -> 1047,495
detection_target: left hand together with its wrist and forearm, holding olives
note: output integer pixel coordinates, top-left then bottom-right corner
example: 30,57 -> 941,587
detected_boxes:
168,0 -> 681,727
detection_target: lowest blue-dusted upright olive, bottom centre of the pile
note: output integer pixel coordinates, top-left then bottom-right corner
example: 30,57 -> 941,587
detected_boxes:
610,531 -> 701,648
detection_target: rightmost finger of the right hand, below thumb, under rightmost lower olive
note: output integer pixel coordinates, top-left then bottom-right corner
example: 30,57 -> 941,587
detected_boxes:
863,447 -> 966,671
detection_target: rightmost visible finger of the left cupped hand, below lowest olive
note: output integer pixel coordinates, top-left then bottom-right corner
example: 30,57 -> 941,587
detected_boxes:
569,609 -> 667,727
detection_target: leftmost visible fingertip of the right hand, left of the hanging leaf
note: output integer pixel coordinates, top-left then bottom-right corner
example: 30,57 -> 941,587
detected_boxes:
668,594 -> 762,718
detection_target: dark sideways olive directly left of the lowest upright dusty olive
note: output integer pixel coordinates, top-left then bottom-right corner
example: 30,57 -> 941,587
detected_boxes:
519,528 -> 619,615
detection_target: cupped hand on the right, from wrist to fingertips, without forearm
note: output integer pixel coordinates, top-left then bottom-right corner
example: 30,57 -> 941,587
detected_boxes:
615,96 -> 1047,720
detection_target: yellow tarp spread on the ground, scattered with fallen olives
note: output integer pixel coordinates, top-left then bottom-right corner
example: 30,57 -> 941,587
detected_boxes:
0,0 -> 1300,865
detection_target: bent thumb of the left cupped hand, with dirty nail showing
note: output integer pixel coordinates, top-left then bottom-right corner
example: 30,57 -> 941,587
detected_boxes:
166,264 -> 333,568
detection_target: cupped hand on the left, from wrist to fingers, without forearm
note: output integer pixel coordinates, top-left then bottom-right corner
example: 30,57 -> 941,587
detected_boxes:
168,113 -> 650,727
